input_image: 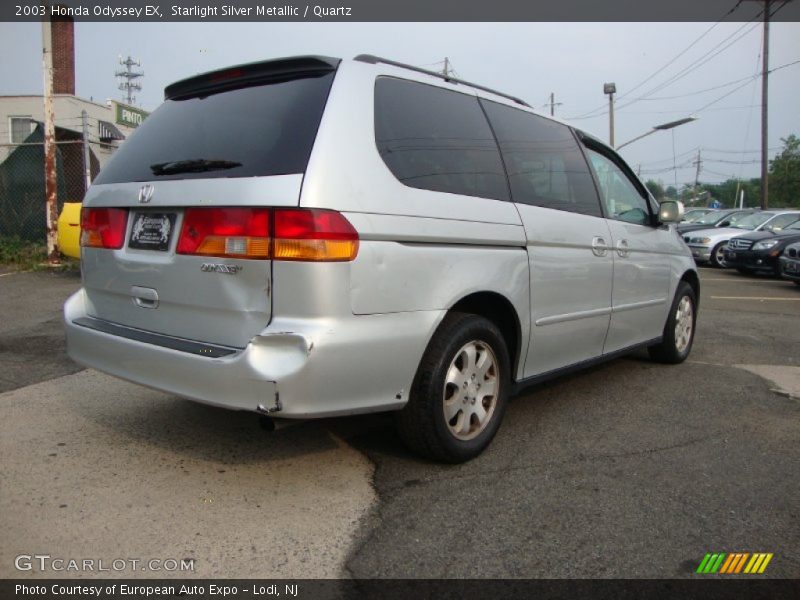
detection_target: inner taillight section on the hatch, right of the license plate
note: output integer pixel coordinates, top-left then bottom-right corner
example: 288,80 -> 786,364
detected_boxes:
178,208 -> 270,258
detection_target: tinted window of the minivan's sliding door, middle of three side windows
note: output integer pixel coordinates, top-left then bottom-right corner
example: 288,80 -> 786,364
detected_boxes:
482,101 -> 601,216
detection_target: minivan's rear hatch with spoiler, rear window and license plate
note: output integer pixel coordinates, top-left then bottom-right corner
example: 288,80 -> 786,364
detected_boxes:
82,57 -> 339,348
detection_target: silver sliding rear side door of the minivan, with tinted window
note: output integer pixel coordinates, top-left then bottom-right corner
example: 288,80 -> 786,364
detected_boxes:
481,100 -> 613,377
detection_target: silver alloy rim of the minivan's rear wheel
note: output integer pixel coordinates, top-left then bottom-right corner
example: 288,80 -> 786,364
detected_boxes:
443,340 -> 500,441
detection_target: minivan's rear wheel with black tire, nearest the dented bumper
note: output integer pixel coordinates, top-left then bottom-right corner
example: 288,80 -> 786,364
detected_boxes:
397,313 -> 511,463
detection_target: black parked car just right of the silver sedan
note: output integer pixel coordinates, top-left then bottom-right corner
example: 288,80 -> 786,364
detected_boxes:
725,218 -> 800,275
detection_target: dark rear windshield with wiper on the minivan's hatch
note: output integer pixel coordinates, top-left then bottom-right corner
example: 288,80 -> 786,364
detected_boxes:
95,72 -> 334,183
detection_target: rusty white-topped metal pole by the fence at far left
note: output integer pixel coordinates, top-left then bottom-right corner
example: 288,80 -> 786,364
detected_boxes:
42,19 -> 61,267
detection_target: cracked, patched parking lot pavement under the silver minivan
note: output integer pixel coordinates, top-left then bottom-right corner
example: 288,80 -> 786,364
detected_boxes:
0,269 -> 800,578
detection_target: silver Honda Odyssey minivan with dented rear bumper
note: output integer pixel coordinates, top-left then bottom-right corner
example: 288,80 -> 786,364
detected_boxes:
64,55 -> 699,462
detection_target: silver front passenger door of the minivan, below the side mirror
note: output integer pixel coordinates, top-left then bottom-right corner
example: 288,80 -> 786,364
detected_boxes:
587,146 -> 673,353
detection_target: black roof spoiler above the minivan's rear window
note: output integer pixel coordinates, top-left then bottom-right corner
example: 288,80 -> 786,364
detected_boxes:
164,56 -> 341,100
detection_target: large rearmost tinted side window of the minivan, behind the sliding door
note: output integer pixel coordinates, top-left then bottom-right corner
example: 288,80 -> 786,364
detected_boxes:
375,77 -> 508,200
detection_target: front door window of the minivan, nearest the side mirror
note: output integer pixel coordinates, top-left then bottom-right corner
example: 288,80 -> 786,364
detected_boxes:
587,150 -> 650,225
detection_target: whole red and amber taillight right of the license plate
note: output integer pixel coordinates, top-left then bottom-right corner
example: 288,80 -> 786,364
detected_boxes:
178,208 -> 358,262
